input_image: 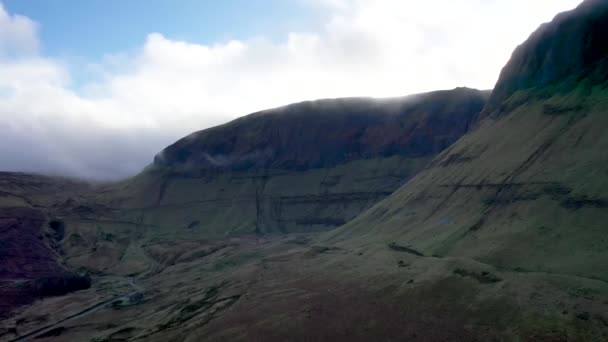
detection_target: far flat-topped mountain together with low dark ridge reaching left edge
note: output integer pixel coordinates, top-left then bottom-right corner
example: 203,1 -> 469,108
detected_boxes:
0,88 -> 489,314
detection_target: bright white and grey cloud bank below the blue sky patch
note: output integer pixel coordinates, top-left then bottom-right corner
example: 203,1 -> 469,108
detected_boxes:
0,0 -> 580,178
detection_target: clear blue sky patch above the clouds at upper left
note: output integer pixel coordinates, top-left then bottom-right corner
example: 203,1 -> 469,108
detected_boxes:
4,0 -> 316,59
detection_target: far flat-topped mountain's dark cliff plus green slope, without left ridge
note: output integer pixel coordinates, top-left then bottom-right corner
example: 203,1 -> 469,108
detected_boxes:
98,88 -> 487,242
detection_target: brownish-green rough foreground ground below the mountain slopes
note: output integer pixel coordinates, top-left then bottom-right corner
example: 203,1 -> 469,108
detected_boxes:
0,235 -> 608,341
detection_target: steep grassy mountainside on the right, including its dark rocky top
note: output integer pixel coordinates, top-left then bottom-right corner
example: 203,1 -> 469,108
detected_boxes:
332,1 -> 608,281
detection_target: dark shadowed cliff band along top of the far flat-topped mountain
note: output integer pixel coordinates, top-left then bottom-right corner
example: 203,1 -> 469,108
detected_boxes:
154,88 -> 486,170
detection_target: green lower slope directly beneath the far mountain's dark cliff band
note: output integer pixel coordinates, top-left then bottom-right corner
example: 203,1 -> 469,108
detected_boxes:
102,157 -> 429,238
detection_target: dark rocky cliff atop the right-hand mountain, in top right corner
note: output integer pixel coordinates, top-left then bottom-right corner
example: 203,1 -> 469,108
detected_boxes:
485,0 -> 608,114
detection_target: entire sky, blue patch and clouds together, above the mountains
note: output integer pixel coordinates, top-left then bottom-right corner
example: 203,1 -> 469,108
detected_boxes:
0,0 -> 581,180
